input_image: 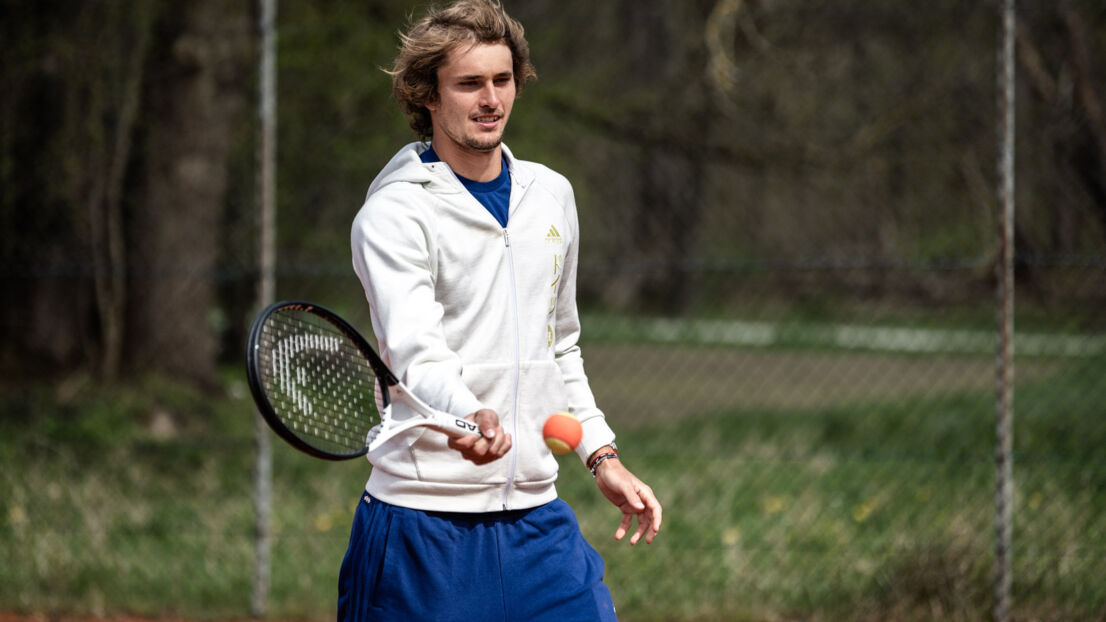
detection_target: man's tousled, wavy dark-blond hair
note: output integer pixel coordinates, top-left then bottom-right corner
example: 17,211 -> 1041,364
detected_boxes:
386,0 -> 538,141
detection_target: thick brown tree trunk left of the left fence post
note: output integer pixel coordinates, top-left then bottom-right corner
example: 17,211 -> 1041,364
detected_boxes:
129,0 -> 250,383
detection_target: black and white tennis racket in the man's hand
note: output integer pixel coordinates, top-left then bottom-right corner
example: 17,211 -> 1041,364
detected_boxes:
246,301 -> 480,460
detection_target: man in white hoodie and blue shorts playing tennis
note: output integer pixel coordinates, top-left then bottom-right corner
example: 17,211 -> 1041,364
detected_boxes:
338,0 -> 661,622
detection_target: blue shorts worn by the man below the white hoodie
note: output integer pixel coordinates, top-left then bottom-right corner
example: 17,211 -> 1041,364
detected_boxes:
337,495 -> 616,622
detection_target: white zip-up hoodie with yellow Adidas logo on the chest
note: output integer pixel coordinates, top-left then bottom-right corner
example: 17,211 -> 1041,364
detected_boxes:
352,143 -> 614,512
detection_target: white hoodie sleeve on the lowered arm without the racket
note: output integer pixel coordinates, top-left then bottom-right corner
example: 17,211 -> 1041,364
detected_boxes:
555,176 -> 615,463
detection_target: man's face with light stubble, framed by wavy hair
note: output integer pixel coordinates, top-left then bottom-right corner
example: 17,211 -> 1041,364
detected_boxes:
426,43 -> 514,155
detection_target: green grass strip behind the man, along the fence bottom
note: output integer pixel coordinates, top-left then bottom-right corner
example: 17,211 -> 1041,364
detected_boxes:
0,349 -> 1106,622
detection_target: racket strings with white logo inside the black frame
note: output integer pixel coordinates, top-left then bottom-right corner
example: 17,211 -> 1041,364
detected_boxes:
259,309 -> 379,454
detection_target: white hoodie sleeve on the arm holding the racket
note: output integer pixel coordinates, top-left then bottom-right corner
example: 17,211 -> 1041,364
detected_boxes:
351,183 -> 483,417
